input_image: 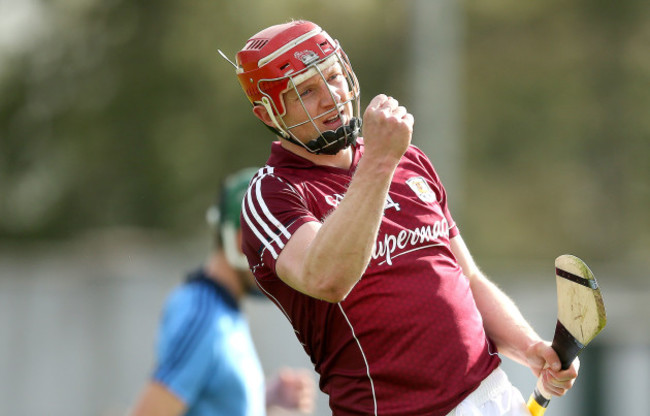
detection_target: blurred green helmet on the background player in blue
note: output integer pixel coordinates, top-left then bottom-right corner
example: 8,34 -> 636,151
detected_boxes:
206,168 -> 258,269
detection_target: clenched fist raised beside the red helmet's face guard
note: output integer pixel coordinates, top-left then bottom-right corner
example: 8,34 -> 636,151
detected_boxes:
363,94 -> 414,162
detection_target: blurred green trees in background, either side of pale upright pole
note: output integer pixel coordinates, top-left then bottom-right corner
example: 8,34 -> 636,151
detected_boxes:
0,0 -> 650,261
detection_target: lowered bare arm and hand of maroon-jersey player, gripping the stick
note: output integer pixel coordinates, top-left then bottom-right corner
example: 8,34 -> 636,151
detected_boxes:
451,235 -> 579,396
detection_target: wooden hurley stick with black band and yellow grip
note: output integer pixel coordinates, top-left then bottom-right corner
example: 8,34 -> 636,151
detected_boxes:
528,254 -> 607,416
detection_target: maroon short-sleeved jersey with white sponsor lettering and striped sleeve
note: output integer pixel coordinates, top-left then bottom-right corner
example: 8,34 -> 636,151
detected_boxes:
242,140 -> 500,416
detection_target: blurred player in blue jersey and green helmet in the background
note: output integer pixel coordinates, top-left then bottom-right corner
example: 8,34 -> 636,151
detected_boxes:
131,168 -> 315,416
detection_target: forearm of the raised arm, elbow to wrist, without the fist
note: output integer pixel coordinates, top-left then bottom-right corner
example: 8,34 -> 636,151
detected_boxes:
302,154 -> 397,302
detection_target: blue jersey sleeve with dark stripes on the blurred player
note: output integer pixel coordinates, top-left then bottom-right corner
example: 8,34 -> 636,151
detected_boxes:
152,289 -> 215,406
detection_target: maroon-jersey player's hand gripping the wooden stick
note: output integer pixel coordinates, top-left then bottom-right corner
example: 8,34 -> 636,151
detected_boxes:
526,341 -> 580,396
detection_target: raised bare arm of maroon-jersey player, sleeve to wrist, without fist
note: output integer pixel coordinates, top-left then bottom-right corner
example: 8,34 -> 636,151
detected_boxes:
276,160 -> 392,302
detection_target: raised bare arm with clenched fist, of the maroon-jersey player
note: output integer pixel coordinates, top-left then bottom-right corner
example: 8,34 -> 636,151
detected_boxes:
276,95 -> 413,302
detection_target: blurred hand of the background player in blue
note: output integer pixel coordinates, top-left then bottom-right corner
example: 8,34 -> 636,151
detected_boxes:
266,368 -> 316,414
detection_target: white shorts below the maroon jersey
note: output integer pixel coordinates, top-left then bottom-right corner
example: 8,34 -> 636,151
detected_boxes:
447,367 -> 530,416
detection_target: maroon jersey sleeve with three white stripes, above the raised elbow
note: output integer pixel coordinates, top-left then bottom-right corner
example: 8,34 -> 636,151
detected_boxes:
241,167 -> 318,278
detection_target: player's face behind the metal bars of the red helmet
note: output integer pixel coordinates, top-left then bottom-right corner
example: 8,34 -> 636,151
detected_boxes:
283,63 -> 352,143
